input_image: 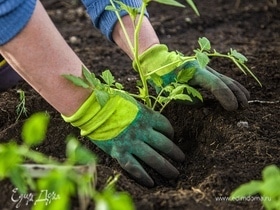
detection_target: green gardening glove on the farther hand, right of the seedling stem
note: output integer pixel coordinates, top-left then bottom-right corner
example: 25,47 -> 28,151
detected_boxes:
133,44 -> 250,111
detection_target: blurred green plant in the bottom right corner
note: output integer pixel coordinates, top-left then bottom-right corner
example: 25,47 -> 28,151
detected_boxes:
230,165 -> 280,210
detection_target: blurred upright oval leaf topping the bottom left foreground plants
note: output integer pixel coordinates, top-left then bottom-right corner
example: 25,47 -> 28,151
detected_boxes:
21,112 -> 50,146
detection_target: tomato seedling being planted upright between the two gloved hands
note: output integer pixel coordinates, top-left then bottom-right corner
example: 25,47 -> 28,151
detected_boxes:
63,0 -> 261,112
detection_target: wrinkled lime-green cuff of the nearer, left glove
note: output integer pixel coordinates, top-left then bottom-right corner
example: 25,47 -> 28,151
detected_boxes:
62,92 -> 138,140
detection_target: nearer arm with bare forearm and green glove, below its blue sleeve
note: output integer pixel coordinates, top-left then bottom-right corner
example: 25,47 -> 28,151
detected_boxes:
0,1 -> 184,186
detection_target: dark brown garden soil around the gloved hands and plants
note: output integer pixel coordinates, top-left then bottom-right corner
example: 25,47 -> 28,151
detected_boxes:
0,0 -> 280,210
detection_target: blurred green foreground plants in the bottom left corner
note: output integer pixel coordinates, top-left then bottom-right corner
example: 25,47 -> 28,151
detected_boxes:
0,113 -> 134,210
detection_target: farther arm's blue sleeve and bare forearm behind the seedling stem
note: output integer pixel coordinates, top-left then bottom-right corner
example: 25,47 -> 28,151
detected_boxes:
82,0 -> 159,59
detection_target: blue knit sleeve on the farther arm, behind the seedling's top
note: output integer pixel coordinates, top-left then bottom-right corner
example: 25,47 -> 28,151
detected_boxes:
82,0 -> 147,41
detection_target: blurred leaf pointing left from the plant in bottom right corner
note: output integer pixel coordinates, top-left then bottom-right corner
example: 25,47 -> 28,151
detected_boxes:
230,180 -> 263,200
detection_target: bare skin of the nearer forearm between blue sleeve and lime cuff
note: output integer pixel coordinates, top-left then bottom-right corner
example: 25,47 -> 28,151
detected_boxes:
0,1 -> 90,116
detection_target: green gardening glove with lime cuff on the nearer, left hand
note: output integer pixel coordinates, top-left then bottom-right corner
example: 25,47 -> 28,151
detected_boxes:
62,92 -> 185,187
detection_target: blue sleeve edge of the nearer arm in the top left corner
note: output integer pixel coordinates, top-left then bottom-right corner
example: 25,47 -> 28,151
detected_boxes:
0,0 -> 36,45
